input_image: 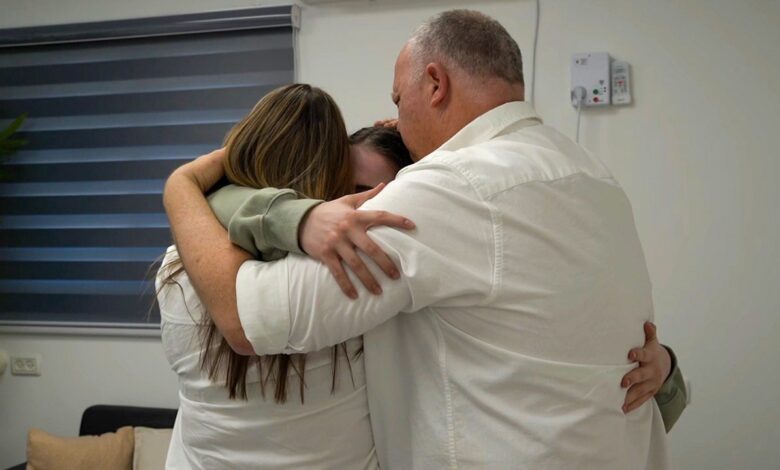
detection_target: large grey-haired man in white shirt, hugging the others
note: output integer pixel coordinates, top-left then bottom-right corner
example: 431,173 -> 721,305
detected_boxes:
165,10 -> 685,469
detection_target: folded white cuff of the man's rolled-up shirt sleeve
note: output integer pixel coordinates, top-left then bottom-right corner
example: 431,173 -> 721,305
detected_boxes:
236,258 -> 290,356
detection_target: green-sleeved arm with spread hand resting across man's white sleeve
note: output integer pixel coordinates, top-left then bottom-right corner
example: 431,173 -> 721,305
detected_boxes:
207,184 -> 414,298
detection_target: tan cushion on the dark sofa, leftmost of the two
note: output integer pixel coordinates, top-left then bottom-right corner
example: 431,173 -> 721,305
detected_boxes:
27,426 -> 134,470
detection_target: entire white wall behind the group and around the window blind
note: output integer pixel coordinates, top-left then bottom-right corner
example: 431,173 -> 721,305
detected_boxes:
0,0 -> 780,469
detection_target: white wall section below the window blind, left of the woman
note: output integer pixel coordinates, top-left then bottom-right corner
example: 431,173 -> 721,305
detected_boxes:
0,334 -> 178,469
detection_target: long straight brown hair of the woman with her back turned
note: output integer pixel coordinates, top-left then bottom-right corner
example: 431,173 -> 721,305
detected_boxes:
161,84 -> 353,403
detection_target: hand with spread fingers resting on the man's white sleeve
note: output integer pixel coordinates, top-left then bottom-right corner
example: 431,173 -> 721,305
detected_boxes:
299,184 -> 414,299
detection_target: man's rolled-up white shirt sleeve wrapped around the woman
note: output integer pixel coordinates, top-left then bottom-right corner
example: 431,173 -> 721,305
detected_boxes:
236,164 -> 495,354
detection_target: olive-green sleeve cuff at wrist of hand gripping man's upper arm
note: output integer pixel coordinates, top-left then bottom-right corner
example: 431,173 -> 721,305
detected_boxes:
263,198 -> 323,255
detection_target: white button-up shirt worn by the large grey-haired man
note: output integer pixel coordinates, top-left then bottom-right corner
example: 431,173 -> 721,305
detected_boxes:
236,102 -> 668,469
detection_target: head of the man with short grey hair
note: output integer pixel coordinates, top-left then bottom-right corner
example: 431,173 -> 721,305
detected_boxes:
393,10 -> 524,159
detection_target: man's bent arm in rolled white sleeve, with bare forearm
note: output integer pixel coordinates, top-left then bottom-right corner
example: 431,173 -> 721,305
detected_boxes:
166,156 -> 493,354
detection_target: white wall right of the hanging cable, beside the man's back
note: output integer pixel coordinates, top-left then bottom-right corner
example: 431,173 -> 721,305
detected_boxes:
537,0 -> 780,469
